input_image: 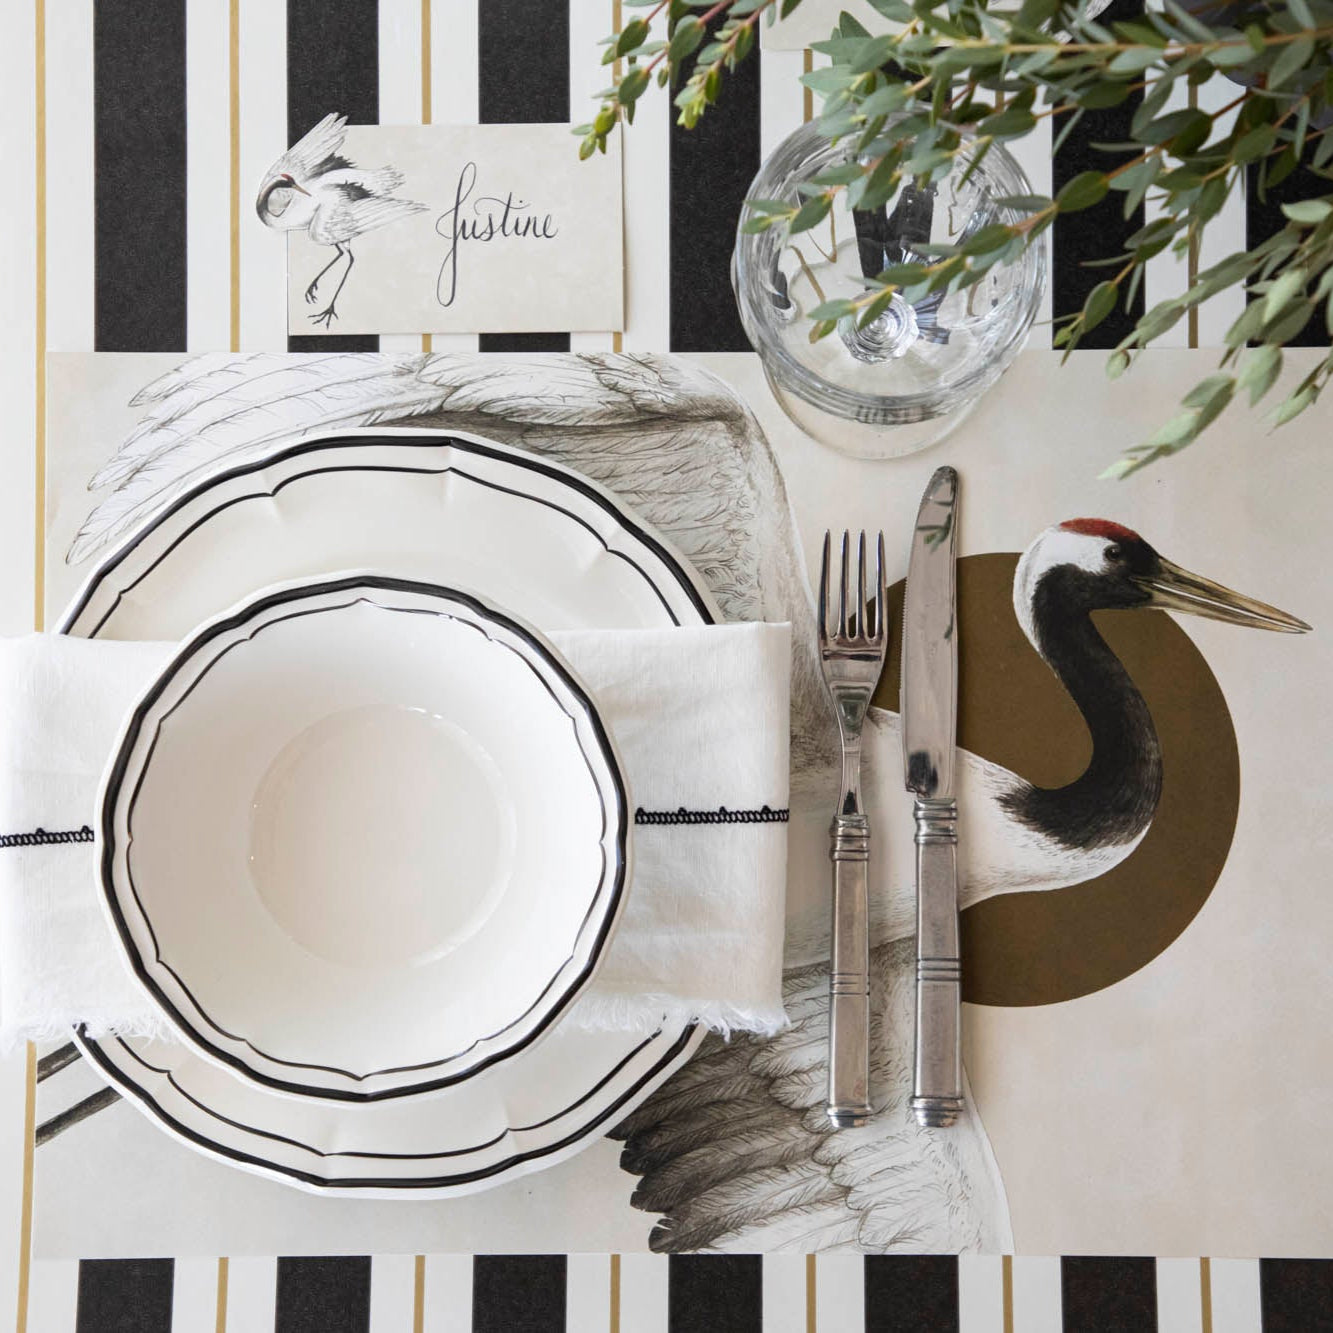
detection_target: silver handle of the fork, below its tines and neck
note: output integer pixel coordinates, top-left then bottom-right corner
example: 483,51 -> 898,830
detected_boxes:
828,814 -> 870,1129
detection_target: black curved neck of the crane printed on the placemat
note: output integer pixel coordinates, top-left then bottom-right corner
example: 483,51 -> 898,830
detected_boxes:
1004,580 -> 1162,850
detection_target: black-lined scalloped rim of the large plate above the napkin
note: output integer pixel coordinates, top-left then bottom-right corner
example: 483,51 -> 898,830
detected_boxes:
57,433 -> 717,639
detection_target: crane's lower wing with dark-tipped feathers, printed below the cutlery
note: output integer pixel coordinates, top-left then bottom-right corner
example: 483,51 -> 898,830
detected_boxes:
615,941 -> 1008,1253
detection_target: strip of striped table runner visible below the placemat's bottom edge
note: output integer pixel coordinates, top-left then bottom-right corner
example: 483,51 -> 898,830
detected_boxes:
20,1254 -> 1333,1333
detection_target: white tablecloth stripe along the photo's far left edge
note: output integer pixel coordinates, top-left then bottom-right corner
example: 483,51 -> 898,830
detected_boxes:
0,5 -> 36,634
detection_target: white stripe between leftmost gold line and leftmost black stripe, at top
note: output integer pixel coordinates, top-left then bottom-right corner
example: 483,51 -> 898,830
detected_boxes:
42,0 -> 96,352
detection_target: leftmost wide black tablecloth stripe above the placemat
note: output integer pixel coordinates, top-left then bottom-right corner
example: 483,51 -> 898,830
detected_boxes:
93,0 -> 185,352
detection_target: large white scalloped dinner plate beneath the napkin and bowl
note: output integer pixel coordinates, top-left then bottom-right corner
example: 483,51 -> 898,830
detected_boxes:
61,429 -> 718,1197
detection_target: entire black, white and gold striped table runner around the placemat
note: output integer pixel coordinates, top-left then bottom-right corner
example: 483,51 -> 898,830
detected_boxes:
0,0 -> 1333,1333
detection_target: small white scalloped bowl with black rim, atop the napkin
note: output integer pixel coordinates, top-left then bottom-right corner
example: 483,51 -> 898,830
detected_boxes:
99,573 -> 629,1101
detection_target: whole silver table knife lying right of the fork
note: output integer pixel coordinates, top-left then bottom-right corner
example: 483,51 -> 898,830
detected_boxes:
902,468 -> 962,1126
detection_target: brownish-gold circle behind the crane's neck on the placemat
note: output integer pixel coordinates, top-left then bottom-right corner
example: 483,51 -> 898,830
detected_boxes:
874,553 -> 1240,1005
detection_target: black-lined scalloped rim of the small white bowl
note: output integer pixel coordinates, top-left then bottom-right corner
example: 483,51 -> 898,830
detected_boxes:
99,575 -> 629,1102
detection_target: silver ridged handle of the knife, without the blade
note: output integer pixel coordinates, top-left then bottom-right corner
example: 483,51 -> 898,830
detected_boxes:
912,797 -> 962,1128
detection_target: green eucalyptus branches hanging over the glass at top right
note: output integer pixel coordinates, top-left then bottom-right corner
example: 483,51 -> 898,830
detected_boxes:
577,0 -> 1333,476
